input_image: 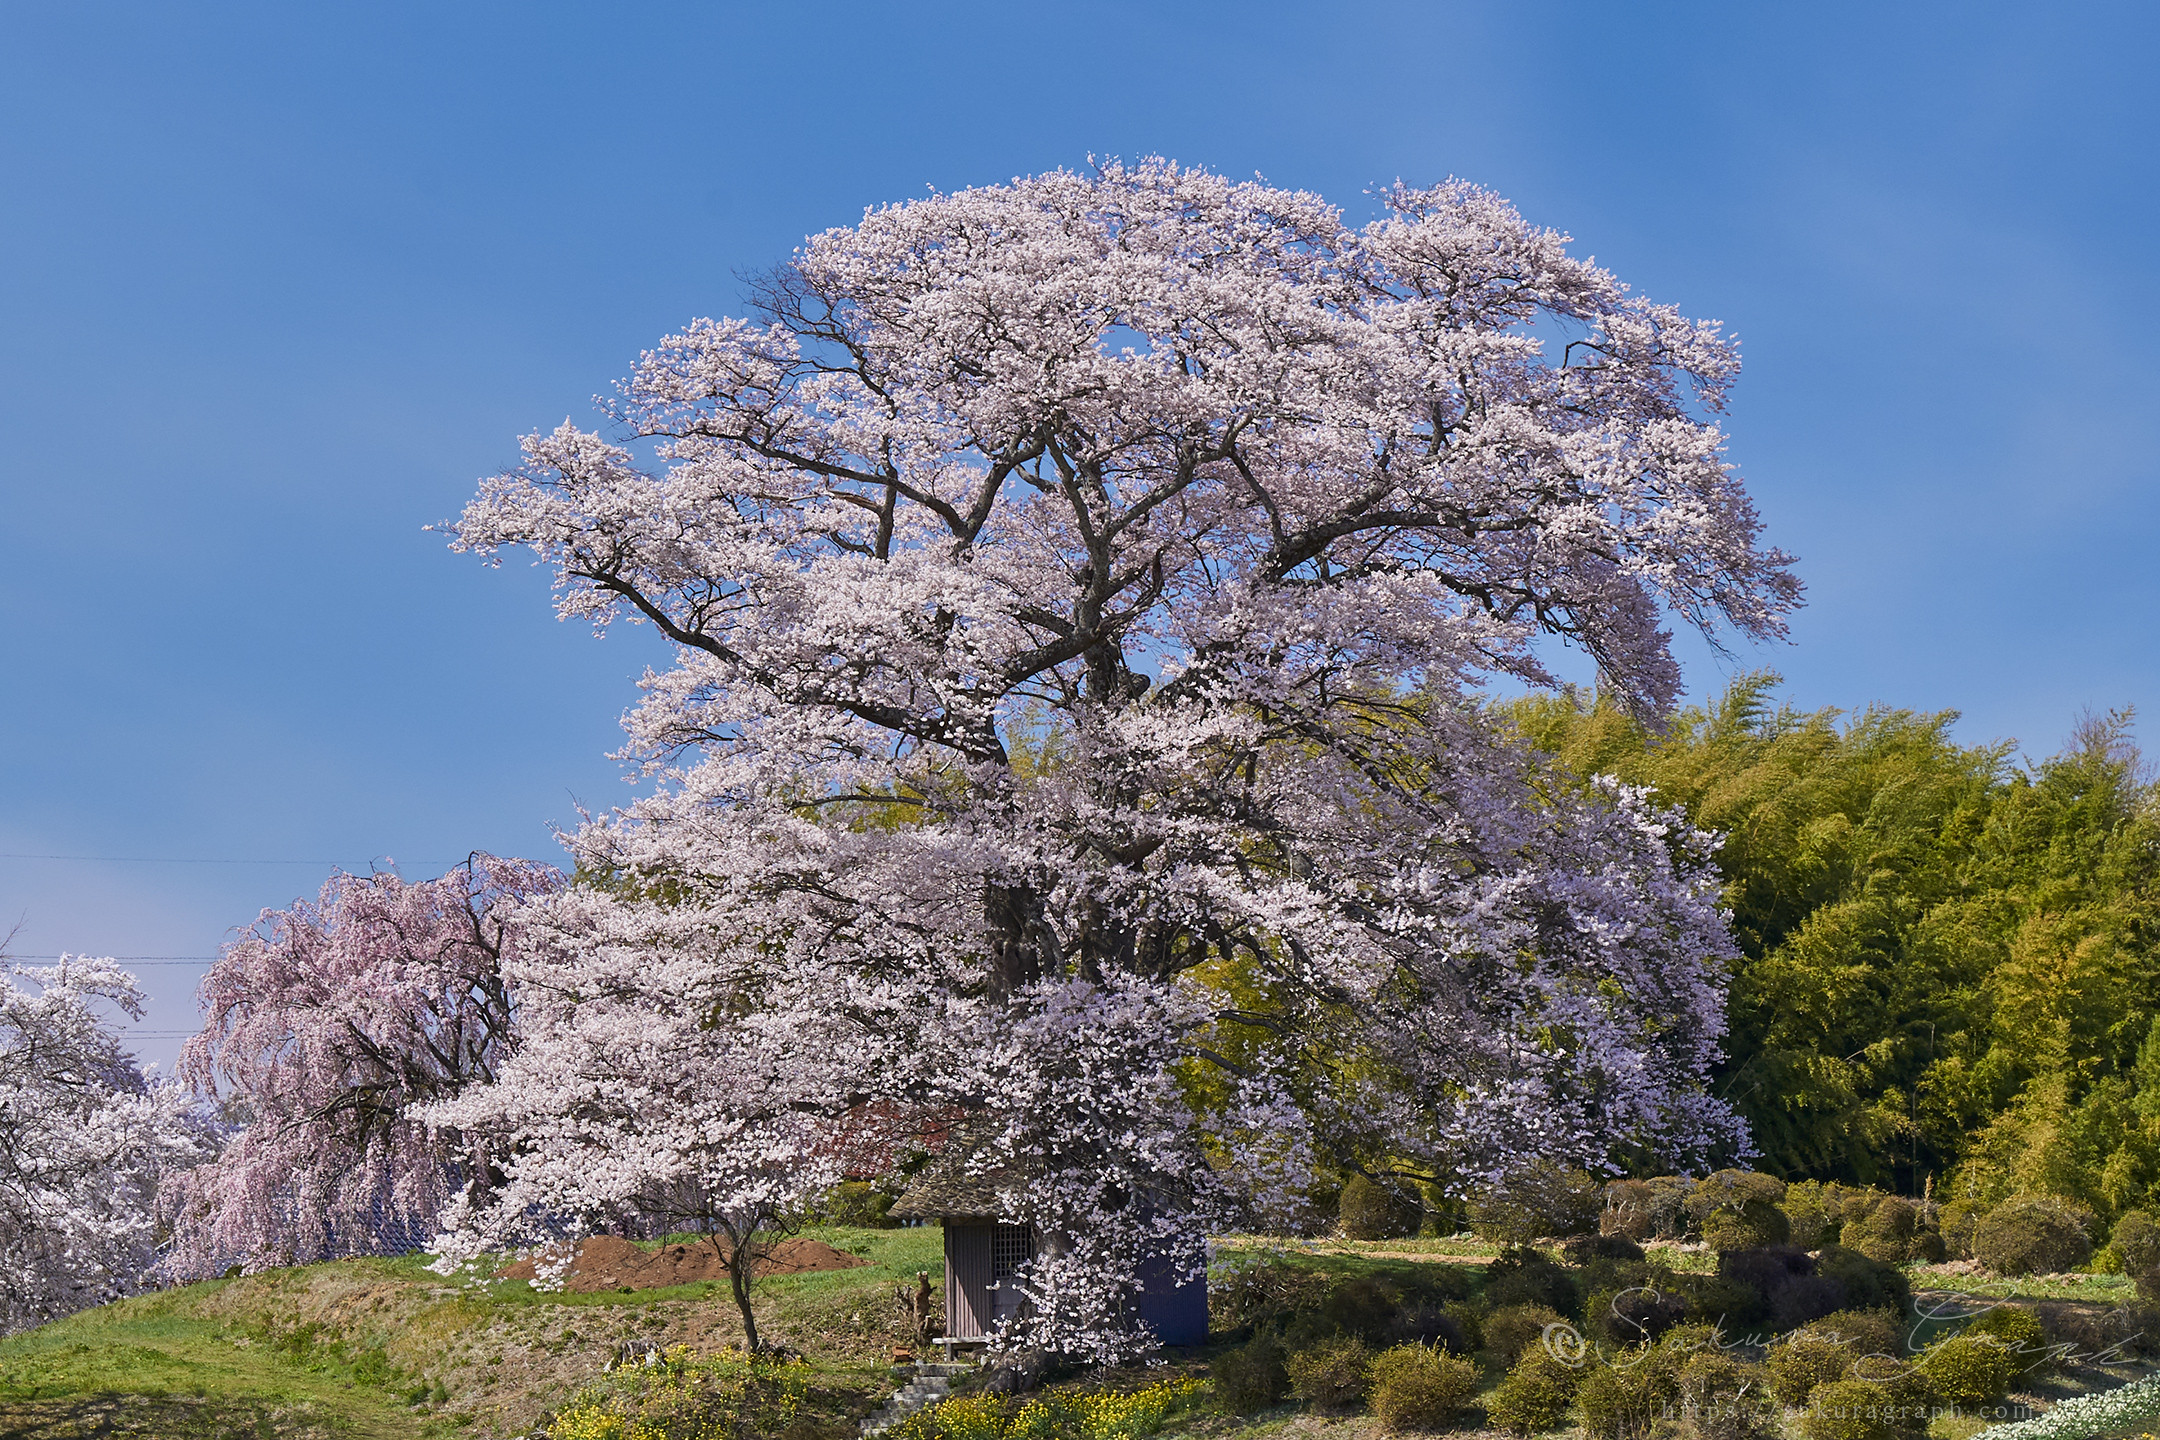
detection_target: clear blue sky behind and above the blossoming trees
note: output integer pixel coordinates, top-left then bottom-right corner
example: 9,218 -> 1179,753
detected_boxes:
0,0 -> 2160,1060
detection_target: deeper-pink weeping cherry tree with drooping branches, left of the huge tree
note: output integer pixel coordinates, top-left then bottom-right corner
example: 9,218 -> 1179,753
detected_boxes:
162,853 -> 562,1276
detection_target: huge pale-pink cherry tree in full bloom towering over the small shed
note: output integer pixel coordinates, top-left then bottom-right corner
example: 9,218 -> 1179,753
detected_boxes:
445,162 -> 1799,1358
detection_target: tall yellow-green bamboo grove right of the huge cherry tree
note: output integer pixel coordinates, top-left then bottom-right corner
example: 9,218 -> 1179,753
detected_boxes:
1501,676 -> 2160,1208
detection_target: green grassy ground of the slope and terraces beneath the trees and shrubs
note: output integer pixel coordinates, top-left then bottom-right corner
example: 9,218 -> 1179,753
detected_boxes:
0,1228 -> 2130,1440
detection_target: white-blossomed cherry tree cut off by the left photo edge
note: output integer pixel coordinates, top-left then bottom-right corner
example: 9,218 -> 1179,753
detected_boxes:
0,956 -> 214,1334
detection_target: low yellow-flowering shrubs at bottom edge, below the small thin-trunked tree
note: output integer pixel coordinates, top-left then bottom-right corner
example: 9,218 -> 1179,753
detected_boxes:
549,1345 -> 810,1440
